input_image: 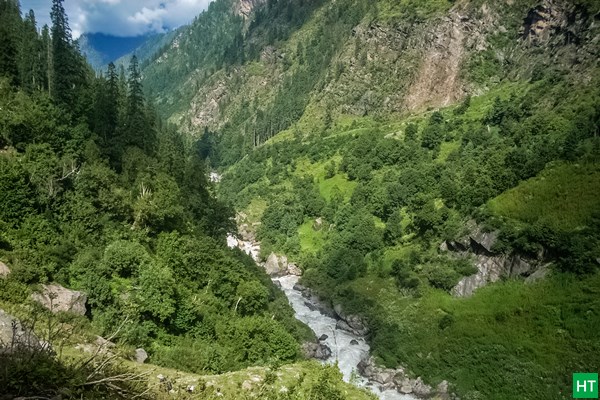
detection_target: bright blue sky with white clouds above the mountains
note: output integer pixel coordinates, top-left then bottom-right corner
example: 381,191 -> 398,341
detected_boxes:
21,0 -> 211,39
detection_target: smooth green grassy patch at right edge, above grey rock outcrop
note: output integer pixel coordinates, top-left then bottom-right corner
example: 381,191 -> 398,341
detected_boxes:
488,163 -> 600,231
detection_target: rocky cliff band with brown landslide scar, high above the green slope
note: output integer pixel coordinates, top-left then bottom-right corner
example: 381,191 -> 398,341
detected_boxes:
142,0 -> 600,147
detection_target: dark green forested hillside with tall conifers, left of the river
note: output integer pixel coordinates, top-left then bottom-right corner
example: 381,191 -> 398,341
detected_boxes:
0,0 -> 376,398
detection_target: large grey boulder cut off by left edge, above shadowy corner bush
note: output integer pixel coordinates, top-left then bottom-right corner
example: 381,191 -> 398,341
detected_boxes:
0,310 -> 45,354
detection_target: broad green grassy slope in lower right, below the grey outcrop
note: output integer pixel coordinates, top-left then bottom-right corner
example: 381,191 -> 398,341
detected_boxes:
342,273 -> 600,400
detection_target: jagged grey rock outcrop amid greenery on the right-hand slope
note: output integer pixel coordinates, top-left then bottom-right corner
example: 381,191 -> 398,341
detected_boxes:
448,220 -> 547,297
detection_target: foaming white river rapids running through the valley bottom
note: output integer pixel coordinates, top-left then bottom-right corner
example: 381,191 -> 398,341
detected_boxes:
227,236 -> 416,400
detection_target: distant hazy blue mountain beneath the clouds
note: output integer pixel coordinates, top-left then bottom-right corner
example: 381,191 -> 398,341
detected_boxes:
78,33 -> 151,70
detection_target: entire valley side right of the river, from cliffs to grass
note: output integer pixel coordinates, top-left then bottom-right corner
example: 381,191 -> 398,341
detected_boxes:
136,0 -> 600,399
